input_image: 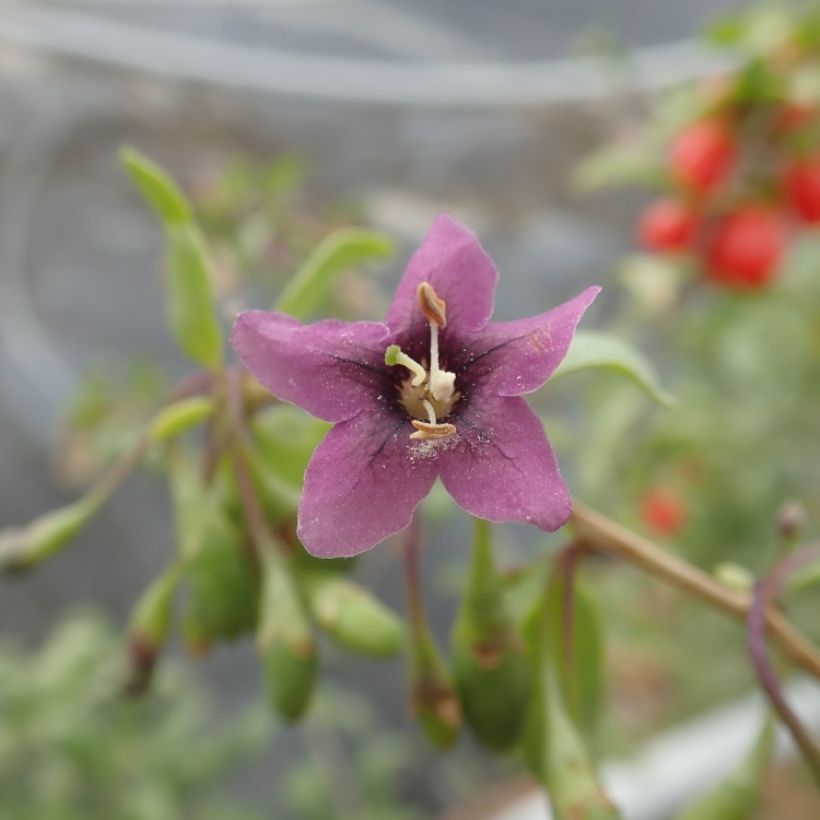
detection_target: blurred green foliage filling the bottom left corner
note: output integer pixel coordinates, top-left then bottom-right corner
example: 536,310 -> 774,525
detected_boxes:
0,612 -> 272,820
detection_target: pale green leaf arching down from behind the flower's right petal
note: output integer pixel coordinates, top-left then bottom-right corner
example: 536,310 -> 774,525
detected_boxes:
552,330 -> 676,407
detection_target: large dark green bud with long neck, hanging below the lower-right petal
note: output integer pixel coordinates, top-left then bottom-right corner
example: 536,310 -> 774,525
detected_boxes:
453,521 -> 530,751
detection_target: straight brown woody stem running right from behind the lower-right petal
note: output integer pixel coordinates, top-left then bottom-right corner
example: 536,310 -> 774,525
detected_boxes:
571,504 -> 820,680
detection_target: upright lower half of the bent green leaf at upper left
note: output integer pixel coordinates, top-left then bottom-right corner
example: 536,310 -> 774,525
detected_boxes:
167,225 -> 222,368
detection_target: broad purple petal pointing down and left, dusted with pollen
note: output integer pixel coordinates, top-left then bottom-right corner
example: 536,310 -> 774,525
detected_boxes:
297,412 -> 438,558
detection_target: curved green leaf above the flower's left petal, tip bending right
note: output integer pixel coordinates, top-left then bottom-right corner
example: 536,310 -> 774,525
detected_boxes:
276,228 -> 394,319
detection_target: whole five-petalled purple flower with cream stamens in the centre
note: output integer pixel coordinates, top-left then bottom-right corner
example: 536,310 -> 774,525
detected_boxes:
232,214 -> 600,557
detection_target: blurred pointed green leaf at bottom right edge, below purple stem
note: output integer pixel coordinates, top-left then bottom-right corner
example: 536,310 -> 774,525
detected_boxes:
678,719 -> 774,820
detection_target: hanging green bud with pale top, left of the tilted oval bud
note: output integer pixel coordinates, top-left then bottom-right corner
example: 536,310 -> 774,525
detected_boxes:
256,553 -> 317,721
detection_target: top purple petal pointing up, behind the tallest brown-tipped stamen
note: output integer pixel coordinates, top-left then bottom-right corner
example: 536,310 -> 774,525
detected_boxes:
385,214 -> 498,333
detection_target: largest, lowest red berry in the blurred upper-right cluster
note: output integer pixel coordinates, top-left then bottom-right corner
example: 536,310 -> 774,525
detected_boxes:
706,205 -> 787,289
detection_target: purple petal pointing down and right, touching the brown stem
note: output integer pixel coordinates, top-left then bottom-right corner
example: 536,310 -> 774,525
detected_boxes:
440,396 -> 572,532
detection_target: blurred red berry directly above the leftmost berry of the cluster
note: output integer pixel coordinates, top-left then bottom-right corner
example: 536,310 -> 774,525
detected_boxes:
669,120 -> 737,192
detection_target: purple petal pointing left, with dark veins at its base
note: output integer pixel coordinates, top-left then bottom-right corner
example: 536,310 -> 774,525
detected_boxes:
231,310 -> 389,421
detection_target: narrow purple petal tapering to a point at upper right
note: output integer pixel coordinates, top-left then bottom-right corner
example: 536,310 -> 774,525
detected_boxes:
457,287 -> 601,396
